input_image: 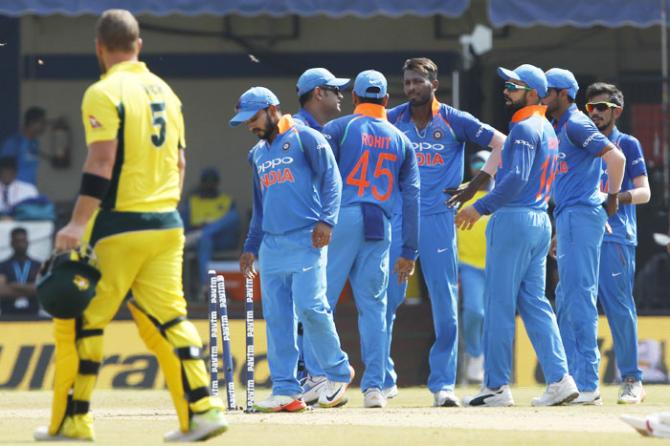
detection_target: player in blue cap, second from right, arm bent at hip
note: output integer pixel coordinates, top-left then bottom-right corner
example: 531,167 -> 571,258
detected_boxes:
543,68 -> 626,405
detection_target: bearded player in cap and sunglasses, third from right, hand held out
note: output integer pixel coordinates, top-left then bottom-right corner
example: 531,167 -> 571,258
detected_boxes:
455,64 -> 578,406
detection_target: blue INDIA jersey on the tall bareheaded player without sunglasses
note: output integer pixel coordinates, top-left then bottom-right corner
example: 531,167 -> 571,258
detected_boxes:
388,99 -> 494,215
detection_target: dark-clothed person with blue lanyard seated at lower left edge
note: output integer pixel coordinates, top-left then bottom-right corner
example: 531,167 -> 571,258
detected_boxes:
0,227 -> 40,315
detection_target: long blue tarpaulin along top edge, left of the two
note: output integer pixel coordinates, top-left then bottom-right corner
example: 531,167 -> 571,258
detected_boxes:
0,0 -> 470,17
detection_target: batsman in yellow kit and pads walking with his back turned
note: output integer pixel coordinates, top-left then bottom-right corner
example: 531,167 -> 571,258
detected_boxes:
35,9 -> 227,441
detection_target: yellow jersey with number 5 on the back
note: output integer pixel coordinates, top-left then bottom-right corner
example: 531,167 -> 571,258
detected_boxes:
81,61 -> 186,212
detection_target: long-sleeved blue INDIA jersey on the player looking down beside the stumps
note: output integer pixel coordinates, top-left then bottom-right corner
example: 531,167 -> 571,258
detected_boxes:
244,115 -> 342,255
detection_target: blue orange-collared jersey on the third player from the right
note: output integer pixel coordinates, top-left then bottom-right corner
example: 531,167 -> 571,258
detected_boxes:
474,105 -> 558,215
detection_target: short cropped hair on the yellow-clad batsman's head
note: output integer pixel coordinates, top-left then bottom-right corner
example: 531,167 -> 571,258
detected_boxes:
95,9 -> 140,53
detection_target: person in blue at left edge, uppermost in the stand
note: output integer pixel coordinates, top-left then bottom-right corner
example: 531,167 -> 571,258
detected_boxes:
0,107 -> 47,186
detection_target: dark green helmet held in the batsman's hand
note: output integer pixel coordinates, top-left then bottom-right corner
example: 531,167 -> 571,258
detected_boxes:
37,247 -> 101,319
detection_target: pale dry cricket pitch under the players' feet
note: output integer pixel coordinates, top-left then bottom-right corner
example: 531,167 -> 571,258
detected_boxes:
0,386 -> 670,446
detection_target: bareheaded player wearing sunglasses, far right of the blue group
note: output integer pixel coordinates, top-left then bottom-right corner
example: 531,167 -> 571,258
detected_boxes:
586,82 -> 651,404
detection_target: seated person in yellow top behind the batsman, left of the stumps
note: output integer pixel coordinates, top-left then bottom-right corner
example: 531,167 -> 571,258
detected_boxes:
182,167 -> 241,288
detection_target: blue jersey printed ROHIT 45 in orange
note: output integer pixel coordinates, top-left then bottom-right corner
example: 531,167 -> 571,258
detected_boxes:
323,103 -> 420,259
